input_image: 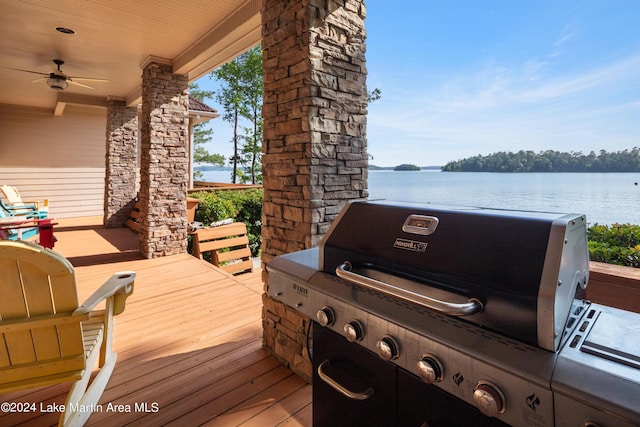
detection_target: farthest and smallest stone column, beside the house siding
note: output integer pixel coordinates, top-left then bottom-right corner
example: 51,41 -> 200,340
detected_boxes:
103,99 -> 138,228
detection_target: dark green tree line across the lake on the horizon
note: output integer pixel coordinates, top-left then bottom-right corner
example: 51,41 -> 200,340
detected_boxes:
441,147 -> 640,172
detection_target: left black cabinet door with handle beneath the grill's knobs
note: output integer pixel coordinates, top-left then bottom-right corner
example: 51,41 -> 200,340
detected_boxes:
313,322 -> 397,427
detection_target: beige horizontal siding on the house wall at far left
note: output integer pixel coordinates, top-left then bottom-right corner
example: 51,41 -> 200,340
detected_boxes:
0,105 -> 106,218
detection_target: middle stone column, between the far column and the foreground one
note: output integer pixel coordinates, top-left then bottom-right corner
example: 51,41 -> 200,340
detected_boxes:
139,62 -> 189,258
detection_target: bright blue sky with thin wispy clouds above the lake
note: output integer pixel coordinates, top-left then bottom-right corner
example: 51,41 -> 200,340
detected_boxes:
200,0 -> 640,166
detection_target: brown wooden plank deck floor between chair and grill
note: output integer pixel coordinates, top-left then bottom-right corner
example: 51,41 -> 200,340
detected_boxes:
0,218 -> 311,427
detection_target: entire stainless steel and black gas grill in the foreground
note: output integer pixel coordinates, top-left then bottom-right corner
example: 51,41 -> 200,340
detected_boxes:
268,202 -> 640,427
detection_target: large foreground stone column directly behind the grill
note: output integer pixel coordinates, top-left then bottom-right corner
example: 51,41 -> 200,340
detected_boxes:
262,0 -> 368,381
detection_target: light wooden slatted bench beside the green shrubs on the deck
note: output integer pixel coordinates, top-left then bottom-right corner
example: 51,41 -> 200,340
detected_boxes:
193,222 -> 253,274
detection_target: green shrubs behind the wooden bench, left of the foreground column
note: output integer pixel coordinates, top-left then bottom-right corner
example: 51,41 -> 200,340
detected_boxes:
190,188 -> 263,256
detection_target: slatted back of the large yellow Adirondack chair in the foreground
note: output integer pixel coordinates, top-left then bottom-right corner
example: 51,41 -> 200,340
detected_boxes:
0,241 -> 85,386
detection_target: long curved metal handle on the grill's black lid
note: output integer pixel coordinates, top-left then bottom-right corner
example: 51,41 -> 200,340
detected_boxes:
336,261 -> 483,316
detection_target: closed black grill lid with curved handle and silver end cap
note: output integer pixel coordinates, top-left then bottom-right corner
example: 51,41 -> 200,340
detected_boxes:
319,202 -> 589,351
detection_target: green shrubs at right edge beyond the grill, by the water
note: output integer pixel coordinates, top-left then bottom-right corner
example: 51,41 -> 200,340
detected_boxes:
587,224 -> 640,268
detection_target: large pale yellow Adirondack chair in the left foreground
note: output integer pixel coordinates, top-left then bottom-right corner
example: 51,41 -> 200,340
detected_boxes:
0,240 -> 136,426
